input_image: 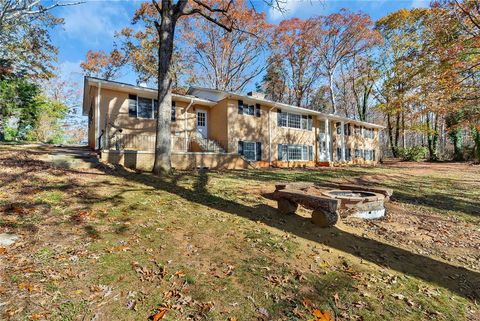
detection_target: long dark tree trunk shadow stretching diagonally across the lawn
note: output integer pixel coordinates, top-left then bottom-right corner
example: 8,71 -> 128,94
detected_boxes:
97,167 -> 480,299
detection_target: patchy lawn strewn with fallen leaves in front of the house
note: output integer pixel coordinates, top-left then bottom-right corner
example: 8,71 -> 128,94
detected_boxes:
0,145 -> 480,321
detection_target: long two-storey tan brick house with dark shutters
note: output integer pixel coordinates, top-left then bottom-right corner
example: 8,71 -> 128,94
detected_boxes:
83,77 -> 384,169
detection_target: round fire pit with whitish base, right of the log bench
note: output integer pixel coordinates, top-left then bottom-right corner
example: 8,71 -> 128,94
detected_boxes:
322,190 -> 385,219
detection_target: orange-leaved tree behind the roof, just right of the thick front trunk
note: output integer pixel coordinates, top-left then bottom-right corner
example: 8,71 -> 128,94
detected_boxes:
180,0 -> 271,91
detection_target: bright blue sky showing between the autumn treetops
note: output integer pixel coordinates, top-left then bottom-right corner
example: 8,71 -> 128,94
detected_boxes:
52,0 -> 428,89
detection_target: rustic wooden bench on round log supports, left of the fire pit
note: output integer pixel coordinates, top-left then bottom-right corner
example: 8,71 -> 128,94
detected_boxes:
273,183 -> 341,227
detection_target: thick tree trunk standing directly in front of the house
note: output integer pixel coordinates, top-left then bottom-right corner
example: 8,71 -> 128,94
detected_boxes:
153,1 -> 176,175
